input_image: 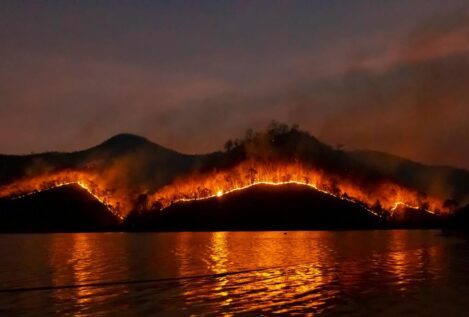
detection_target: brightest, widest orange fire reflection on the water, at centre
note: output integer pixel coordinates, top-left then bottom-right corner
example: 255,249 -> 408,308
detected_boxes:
174,232 -> 338,316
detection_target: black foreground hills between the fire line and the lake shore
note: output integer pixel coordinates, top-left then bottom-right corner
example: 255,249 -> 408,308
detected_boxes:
0,180 -> 454,232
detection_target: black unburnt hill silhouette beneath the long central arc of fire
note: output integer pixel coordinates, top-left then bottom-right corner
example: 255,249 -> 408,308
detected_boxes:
124,184 -> 386,231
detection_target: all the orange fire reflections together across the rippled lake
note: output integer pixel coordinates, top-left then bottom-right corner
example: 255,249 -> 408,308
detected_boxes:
36,231 -> 445,316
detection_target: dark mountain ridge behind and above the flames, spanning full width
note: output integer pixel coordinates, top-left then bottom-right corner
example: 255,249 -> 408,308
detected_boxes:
0,123 -> 469,217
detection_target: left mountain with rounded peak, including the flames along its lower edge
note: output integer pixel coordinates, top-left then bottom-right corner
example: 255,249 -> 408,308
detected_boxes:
0,134 -> 200,217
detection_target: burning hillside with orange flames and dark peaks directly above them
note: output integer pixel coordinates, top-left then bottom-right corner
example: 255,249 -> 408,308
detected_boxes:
0,123 -> 464,223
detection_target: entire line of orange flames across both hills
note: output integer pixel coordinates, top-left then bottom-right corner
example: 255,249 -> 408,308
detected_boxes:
0,160 -> 447,219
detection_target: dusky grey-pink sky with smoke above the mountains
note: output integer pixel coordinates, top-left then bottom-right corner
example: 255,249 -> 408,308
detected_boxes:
0,0 -> 469,168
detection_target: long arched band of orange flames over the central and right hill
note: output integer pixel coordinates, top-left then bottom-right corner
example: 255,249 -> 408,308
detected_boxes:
150,161 -> 446,215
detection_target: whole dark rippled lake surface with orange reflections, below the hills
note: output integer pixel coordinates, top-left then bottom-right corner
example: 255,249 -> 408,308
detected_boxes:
0,230 -> 469,316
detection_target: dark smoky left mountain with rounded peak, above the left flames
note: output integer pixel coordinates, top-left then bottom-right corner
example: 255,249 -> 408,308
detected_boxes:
0,134 -> 210,188
